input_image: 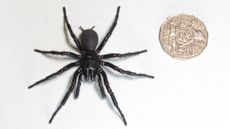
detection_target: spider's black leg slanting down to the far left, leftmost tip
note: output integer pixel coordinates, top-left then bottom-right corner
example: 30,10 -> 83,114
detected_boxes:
28,62 -> 79,89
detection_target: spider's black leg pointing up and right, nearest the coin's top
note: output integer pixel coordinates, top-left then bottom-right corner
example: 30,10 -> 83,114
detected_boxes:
96,6 -> 120,53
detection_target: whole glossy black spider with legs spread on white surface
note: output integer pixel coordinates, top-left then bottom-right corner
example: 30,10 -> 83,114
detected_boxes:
28,6 -> 154,125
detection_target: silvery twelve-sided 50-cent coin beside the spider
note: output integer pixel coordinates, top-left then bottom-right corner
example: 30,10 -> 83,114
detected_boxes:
159,14 -> 208,59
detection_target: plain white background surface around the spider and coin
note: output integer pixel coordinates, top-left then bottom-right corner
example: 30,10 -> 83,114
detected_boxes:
0,0 -> 230,129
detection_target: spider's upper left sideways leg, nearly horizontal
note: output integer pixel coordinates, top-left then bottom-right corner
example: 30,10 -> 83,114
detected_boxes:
34,49 -> 80,59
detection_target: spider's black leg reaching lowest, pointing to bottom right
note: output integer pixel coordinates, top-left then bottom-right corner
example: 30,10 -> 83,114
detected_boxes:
100,69 -> 127,125
